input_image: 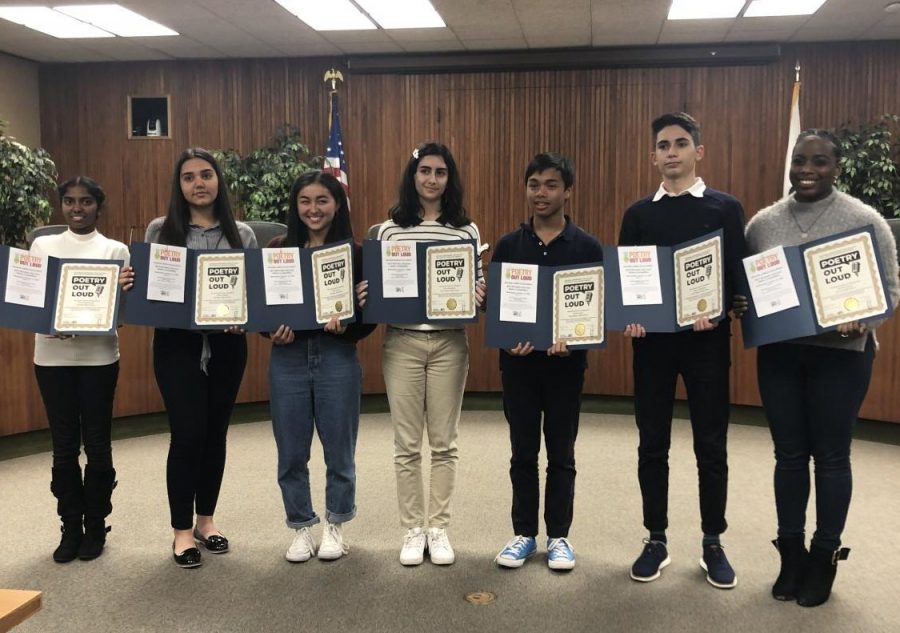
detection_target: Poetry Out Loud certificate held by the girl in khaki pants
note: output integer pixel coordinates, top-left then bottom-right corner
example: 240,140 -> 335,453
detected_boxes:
425,244 -> 475,319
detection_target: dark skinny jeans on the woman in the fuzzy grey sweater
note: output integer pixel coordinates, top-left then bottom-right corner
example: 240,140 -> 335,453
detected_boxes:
756,337 -> 875,550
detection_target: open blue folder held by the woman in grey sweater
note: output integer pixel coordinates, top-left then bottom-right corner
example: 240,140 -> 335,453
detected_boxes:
739,225 -> 894,349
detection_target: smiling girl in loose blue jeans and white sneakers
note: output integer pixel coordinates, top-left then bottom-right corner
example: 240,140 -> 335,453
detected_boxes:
269,171 -> 375,563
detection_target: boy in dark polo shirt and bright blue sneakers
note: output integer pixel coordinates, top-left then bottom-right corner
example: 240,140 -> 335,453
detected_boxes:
492,153 -> 603,570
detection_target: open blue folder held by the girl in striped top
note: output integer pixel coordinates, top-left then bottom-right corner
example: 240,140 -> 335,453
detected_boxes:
363,240 -> 479,325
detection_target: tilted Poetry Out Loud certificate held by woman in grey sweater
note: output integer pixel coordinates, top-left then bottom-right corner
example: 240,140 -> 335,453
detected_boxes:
803,233 -> 887,327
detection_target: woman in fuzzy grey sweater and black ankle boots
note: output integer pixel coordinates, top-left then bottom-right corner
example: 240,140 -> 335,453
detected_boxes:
747,130 -> 900,607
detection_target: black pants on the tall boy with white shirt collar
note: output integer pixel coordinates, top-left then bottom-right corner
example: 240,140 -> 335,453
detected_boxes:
634,323 -> 731,534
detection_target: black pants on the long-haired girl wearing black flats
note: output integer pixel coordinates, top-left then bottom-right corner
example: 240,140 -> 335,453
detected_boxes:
153,329 -> 247,530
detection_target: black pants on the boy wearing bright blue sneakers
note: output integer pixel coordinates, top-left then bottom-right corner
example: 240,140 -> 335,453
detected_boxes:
501,360 -> 584,538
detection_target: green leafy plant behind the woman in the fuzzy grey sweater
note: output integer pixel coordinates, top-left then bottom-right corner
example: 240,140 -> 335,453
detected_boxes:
835,114 -> 900,218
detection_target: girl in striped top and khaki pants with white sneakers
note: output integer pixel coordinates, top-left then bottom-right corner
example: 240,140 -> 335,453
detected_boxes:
359,142 -> 484,565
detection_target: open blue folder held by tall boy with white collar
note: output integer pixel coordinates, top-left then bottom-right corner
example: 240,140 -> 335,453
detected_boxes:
603,229 -> 726,332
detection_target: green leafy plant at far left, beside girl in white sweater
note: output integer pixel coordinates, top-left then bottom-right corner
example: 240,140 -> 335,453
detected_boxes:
0,121 -> 57,246
